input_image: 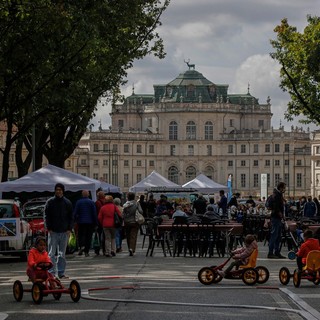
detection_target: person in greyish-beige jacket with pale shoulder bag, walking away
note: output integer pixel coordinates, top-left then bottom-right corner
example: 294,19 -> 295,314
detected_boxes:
123,192 -> 143,256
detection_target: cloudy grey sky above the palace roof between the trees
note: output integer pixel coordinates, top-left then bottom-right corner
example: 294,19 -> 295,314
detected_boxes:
93,0 -> 320,130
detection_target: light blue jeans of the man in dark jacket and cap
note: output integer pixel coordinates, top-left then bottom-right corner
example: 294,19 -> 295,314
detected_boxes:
48,232 -> 69,277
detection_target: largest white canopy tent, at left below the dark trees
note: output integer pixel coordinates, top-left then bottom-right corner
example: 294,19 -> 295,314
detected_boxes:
0,164 -> 120,201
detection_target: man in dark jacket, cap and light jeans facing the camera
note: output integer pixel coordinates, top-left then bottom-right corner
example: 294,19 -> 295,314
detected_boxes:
45,183 -> 73,279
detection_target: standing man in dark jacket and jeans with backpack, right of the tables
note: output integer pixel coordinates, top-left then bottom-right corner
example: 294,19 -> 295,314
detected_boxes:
268,182 -> 286,259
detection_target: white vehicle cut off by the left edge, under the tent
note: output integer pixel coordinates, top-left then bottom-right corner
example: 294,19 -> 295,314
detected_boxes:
0,199 -> 32,260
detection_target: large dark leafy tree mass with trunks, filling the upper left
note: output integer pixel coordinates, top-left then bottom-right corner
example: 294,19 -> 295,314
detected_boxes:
0,0 -> 169,181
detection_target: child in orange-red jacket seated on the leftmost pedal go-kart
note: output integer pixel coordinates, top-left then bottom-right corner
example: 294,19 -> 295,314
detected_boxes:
27,237 -> 53,282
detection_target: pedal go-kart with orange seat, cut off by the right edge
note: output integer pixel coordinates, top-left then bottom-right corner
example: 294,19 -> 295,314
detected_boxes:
279,250 -> 320,288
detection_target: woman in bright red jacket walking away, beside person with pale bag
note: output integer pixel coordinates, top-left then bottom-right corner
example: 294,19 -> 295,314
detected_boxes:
98,196 -> 122,257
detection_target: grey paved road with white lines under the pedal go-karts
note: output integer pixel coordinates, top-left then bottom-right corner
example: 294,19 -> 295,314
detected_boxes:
0,239 -> 320,320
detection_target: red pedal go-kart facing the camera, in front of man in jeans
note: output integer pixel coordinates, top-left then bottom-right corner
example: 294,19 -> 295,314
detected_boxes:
13,262 -> 81,304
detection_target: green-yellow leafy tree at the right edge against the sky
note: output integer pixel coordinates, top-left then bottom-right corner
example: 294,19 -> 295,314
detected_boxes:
270,16 -> 320,124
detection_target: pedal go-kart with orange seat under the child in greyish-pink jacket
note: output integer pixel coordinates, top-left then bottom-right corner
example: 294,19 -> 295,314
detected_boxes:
198,250 -> 270,286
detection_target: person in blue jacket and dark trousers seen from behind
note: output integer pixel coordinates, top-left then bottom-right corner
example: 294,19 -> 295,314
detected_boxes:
73,190 -> 98,257
